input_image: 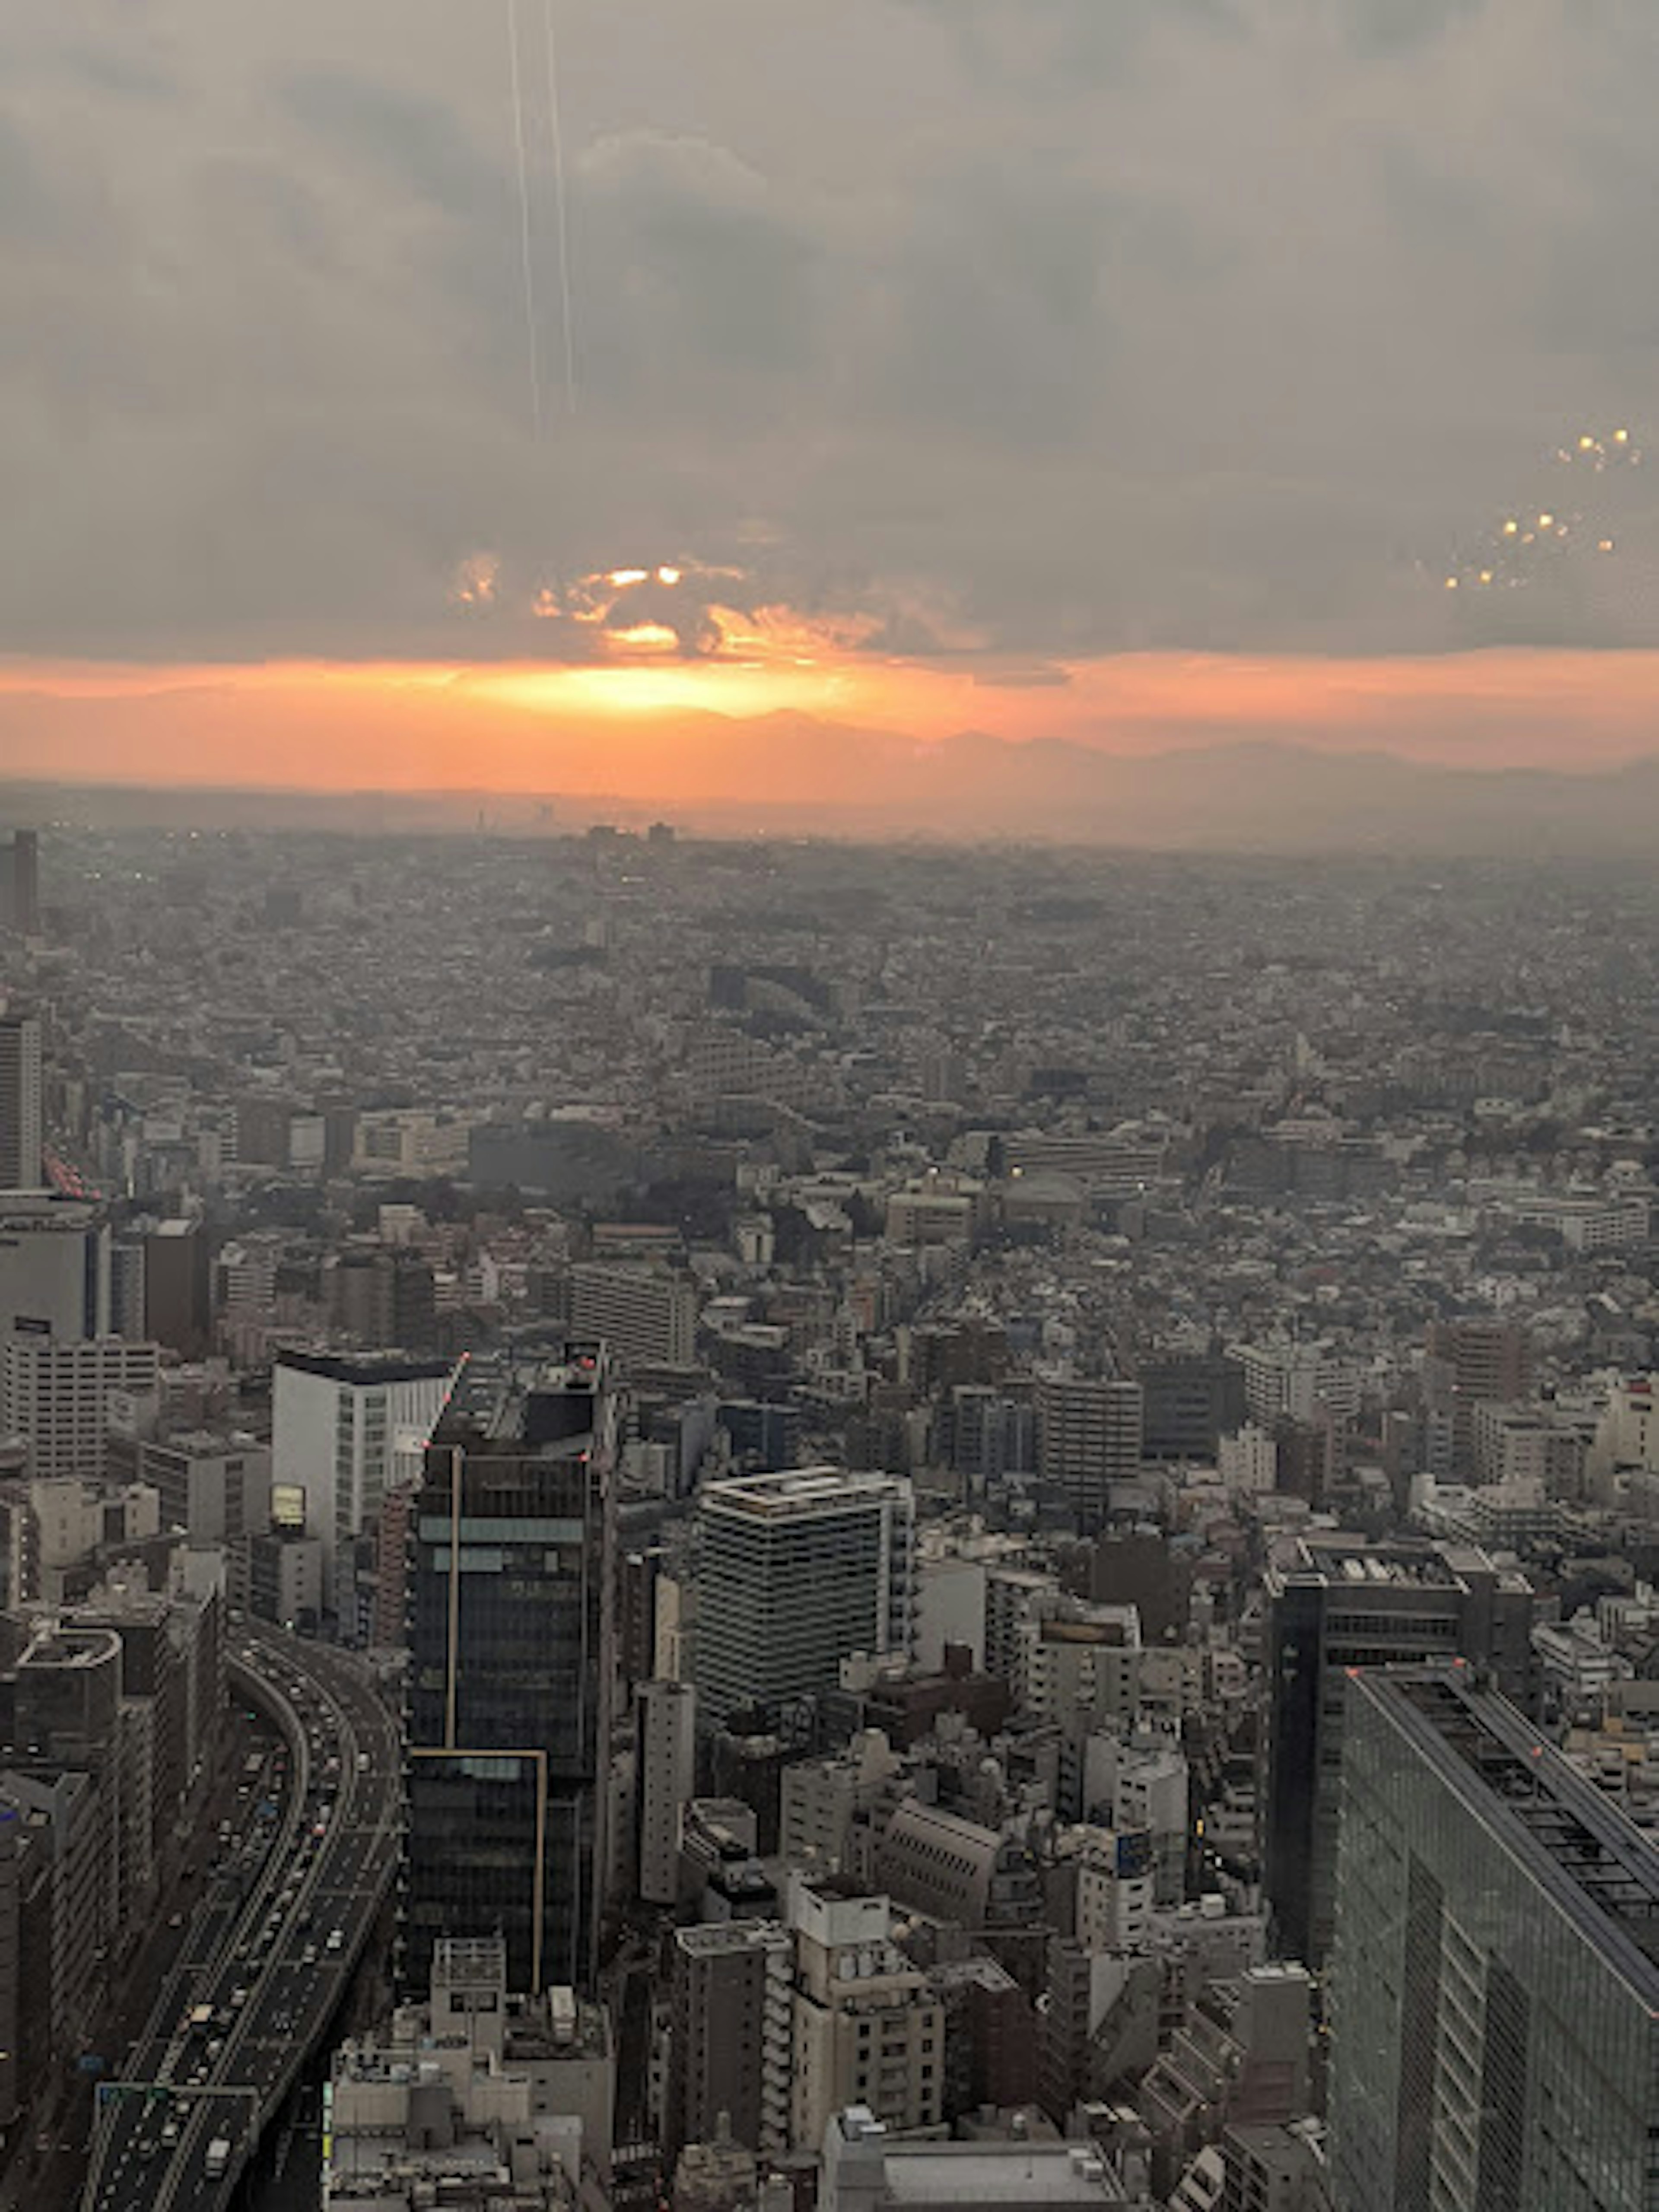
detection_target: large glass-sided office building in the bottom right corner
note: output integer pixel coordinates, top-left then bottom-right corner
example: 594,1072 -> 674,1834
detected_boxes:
1329,1665 -> 1659,2212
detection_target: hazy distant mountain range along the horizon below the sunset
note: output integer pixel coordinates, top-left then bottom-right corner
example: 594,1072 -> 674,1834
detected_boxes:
0,715 -> 1659,858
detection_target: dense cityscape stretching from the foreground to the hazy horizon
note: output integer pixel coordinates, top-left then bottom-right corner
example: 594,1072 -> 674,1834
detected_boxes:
0,816 -> 1659,2212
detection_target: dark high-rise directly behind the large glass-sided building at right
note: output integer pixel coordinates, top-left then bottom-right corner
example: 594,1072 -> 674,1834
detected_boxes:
1256,1535 -> 1535,1967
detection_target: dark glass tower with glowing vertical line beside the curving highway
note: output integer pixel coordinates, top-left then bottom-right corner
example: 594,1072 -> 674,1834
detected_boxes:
400,1341 -> 617,1993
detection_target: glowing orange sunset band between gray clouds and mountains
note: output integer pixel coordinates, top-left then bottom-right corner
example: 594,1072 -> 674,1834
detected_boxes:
0,641 -> 1659,805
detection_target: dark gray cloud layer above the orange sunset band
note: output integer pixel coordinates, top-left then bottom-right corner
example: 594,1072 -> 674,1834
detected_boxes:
0,0 -> 1659,664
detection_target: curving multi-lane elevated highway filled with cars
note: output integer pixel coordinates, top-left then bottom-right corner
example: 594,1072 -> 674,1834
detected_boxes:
82,1621 -> 398,2212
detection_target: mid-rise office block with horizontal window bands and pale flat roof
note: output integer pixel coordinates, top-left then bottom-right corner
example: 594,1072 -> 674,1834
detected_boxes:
697,1467 -> 916,1728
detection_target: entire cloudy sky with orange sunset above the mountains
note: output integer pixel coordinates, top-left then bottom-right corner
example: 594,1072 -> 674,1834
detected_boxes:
0,0 -> 1659,801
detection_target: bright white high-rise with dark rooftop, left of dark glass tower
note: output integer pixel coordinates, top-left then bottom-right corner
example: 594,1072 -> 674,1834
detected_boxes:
270,1351 -> 456,1610
